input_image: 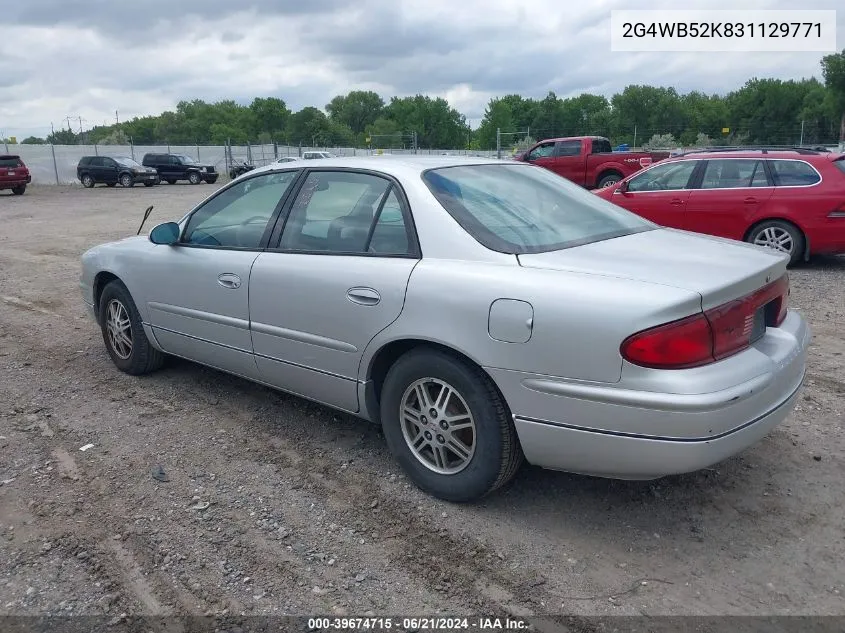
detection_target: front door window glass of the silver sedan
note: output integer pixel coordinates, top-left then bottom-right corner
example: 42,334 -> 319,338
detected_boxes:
182,171 -> 297,248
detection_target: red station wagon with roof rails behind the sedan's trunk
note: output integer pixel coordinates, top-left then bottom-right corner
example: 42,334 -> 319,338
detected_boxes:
596,148 -> 845,264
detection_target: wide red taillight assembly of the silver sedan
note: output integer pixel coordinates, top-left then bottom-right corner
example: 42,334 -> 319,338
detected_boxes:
620,275 -> 789,369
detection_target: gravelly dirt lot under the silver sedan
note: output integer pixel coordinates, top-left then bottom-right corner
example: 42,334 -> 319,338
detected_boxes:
0,185 -> 845,618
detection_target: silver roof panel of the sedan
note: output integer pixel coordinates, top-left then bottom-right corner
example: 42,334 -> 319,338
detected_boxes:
241,154 -> 516,177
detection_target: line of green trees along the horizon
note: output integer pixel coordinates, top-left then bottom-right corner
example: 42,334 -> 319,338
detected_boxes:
13,50 -> 845,149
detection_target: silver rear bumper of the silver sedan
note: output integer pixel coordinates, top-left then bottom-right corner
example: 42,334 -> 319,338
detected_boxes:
488,312 -> 810,479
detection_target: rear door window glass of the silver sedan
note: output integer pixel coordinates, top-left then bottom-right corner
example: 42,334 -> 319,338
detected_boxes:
280,171 -> 396,253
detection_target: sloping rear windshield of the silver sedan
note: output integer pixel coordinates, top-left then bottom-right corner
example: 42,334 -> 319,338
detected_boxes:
423,164 -> 656,254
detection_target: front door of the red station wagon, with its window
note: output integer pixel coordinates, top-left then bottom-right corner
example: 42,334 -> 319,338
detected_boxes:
610,160 -> 699,229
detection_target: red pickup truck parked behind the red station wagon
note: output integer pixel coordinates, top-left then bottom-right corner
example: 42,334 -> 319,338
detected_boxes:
514,136 -> 669,189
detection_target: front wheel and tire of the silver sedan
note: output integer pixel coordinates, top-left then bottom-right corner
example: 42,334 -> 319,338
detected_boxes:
100,281 -> 165,376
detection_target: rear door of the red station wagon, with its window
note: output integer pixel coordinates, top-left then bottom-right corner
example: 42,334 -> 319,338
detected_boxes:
683,157 -> 774,240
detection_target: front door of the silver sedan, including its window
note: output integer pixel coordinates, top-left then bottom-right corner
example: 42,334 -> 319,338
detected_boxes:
144,170 -> 299,378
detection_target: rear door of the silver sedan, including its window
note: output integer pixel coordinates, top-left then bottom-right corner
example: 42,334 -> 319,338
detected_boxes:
249,169 -> 419,412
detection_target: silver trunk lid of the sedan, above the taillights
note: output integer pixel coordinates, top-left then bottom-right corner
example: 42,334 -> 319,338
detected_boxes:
518,228 -> 789,310
